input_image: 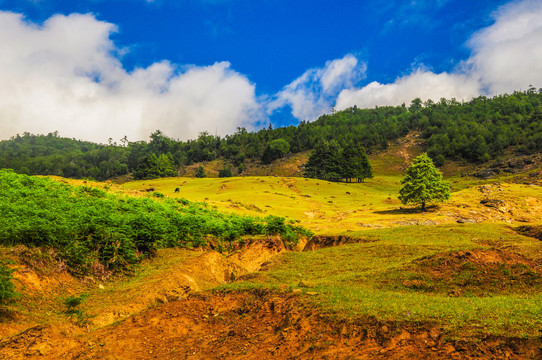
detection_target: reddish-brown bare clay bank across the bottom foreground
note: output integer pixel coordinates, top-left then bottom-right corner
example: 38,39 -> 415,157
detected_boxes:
0,291 -> 542,360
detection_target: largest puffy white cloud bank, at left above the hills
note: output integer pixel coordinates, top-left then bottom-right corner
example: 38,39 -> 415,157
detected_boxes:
0,12 -> 260,142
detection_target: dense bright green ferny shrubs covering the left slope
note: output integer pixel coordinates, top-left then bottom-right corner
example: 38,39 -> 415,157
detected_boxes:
0,170 -> 306,274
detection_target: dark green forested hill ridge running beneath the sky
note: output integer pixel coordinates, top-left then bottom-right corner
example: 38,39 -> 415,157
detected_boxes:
0,88 -> 542,180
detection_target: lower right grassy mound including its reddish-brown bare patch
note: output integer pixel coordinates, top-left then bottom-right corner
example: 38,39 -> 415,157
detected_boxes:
227,224 -> 542,337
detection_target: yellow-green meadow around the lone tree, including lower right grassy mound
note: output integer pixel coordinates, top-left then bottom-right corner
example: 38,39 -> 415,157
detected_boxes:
123,160 -> 542,337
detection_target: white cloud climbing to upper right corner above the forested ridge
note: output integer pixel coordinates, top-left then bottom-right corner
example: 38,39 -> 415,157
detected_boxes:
337,0 -> 542,109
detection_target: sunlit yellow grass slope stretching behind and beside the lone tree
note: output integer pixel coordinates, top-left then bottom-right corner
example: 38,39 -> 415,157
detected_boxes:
123,175 -> 542,234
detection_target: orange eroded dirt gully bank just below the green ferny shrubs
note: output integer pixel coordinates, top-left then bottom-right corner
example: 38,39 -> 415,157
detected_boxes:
0,237 -> 286,338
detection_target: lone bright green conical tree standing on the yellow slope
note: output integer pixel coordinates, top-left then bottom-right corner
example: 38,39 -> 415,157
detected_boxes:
399,153 -> 450,211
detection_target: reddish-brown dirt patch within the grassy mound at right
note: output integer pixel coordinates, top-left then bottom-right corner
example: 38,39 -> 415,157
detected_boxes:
399,249 -> 542,296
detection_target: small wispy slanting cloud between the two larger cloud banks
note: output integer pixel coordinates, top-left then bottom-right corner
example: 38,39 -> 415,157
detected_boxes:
267,54 -> 366,121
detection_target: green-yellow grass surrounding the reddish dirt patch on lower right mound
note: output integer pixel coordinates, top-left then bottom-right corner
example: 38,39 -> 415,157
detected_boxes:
227,224 -> 542,336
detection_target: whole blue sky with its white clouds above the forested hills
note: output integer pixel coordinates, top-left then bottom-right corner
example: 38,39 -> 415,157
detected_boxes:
0,0 -> 542,141
